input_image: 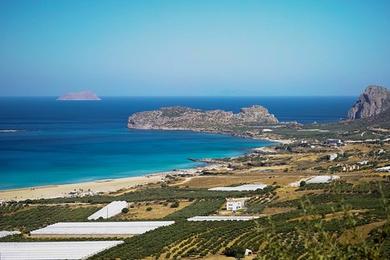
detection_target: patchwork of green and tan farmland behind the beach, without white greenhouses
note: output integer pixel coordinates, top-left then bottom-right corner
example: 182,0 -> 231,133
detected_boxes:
0,144 -> 390,259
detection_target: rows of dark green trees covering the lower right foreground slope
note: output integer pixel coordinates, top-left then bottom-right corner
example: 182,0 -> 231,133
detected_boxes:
93,181 -> 390,259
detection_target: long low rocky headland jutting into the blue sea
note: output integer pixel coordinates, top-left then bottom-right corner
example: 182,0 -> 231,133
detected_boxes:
128,106 -> 278,132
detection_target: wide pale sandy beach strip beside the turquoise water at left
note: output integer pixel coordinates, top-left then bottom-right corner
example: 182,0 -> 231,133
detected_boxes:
0,173 -> 164,201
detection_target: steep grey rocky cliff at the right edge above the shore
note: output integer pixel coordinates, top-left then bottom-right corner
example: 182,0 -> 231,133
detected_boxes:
348,86 -> 390,120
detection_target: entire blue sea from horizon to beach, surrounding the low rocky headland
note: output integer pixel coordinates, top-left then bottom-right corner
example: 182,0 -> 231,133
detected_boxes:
0,97 -> 355,189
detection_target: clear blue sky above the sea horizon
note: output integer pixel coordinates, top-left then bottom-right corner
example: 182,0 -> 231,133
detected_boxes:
0,0 -> 390,96
